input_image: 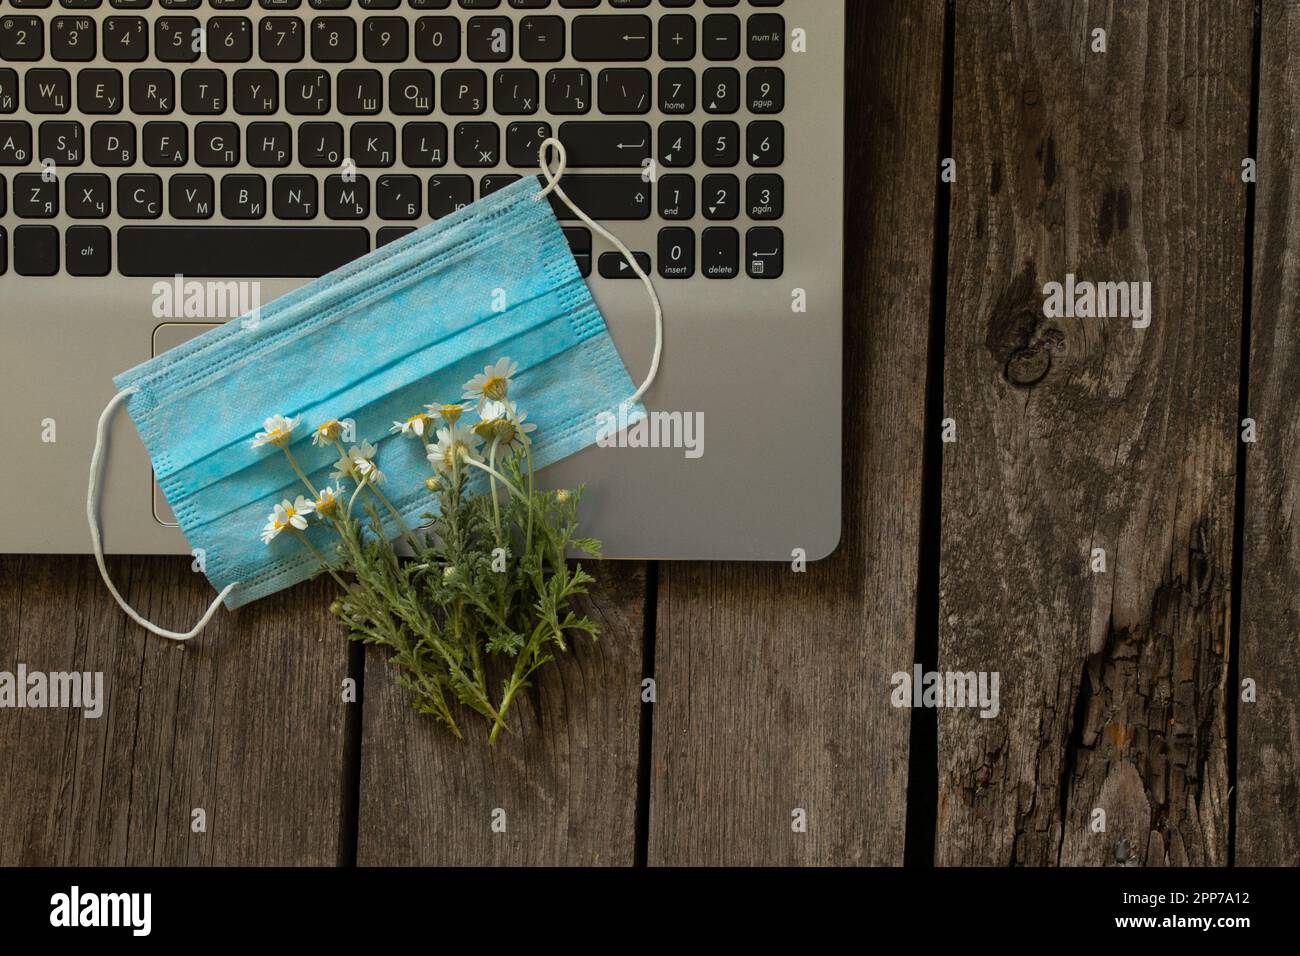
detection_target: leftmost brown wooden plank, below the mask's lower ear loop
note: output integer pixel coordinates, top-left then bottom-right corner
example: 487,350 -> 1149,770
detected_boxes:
0,555 -> 346,865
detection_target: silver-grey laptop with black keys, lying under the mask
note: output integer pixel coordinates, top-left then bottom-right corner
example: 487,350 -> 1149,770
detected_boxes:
0,0 -> 845,561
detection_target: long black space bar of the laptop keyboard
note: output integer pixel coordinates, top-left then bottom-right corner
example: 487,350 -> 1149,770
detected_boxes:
117,226 -> 371,278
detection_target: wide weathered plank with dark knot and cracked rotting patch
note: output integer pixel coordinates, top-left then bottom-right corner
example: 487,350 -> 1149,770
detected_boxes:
936,0 -> 1252,865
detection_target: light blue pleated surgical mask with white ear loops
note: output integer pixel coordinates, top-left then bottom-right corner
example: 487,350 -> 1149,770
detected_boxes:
87,140 -> 662,639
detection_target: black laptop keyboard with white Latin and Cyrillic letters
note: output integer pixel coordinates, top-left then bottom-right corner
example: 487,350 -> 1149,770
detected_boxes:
0,0 -> 787,280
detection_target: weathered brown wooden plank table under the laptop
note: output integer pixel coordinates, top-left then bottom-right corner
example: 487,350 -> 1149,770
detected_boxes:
0,0 -> 1300,865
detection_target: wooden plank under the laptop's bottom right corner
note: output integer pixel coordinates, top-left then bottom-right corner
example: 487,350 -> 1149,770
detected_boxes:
649,1 -> 944,865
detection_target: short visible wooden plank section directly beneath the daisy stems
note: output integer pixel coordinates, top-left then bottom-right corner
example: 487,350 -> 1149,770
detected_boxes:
358,562 -> 646,866
